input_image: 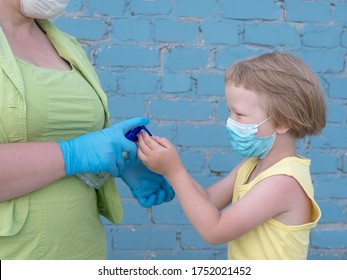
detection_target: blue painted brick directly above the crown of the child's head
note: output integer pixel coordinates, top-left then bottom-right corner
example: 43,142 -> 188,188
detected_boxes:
245,24 -> 300,47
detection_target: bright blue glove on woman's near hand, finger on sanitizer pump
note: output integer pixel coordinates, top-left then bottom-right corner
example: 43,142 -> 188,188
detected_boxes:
58,118 -> 149,177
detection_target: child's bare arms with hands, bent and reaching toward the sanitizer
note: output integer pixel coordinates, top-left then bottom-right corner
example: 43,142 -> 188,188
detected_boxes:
138,134 -> 295,244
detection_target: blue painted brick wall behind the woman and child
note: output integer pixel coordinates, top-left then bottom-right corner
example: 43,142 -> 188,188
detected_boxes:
55,0 -> 347,259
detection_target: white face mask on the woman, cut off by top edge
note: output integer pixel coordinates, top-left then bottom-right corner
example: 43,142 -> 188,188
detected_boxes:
20,0 -> 69,19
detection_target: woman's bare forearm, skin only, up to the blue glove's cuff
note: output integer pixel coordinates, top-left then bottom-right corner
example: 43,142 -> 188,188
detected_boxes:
0,142 -> 66,201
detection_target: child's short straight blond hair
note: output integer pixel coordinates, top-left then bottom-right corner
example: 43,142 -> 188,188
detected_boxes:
225,52 -> 327,138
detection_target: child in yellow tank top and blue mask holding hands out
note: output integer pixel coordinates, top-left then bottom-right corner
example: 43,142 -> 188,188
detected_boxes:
137,52 -> 326,259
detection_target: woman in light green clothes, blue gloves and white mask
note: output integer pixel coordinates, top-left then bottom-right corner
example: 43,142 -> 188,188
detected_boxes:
0,0 -> 173,259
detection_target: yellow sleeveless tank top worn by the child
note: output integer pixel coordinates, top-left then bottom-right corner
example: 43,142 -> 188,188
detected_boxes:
228,157 -> 321,260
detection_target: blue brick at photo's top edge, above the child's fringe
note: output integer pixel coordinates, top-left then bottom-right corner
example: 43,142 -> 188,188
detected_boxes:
221,0 -> 281,20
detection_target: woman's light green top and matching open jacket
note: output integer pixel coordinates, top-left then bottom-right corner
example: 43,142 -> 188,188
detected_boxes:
0,21 -> 122,259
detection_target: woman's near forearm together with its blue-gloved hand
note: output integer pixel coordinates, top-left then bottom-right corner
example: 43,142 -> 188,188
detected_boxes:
0,118 -> 149,201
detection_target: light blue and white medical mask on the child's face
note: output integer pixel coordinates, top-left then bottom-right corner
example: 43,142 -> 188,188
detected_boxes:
226,118 -> 276,158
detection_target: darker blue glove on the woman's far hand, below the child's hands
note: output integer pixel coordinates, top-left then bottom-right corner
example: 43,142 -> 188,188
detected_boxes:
120,158 -> 175,207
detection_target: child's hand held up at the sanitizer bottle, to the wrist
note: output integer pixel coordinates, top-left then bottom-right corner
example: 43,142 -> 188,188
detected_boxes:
137,133 -> 183,177
